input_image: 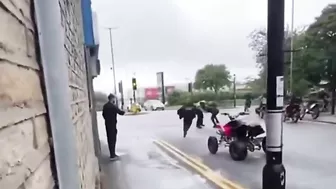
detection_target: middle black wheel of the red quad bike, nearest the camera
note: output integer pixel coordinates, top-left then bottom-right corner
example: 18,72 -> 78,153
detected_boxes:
229,140 -> 247,161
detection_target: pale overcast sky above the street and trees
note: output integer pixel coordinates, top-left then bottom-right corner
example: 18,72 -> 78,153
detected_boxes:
92,0 -> 332,93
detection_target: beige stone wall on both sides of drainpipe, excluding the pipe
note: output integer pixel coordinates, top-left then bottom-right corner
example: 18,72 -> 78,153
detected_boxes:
0,0 -> 99,189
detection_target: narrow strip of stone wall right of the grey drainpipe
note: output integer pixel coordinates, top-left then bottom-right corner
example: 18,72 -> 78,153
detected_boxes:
59,0 -> 99,189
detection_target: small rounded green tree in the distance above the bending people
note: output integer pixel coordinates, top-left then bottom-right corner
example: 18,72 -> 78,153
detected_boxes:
194,64 -> 231,93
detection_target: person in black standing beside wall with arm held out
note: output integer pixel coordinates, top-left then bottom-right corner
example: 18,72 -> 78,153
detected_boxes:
103,94 -> 125,160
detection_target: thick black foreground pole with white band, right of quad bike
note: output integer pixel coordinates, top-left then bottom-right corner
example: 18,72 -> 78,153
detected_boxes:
262,0 -> 286,189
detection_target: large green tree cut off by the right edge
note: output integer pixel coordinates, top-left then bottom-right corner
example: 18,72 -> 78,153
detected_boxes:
302,4 -> 336,114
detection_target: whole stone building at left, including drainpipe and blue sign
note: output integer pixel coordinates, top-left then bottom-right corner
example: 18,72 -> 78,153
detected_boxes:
0,0 -> 99,189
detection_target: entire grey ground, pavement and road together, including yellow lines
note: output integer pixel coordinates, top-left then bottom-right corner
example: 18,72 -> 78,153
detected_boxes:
98,107 -> 336,189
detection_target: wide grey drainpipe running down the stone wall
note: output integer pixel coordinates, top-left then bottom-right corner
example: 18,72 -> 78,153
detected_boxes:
34,0 -> 80,189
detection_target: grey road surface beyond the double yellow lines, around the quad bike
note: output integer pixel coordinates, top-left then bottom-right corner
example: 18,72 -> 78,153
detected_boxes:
106,109 -> 336,189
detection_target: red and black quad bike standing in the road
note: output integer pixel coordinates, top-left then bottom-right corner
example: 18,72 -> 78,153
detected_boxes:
208,112 -> 266,161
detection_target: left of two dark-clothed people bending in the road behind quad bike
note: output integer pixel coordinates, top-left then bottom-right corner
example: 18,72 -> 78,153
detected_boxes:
177,102 -> 196,138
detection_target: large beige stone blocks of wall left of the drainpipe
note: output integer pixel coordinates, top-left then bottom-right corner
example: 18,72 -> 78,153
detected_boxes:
0,0 -> 54,189
